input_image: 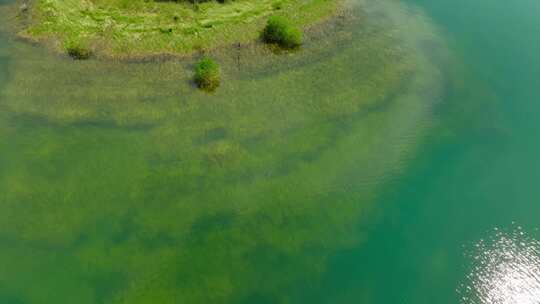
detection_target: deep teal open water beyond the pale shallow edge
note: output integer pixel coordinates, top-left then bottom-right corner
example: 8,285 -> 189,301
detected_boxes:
324,0 -> 540,304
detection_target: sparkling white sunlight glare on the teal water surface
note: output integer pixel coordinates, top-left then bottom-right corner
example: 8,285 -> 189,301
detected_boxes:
458,227 -> 540,304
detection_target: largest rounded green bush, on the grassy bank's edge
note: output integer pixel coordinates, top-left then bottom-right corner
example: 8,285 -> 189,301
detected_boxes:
262,16 -> 302,48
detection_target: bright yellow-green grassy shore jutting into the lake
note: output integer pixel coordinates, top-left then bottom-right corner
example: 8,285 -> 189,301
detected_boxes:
20,0 -> 341,58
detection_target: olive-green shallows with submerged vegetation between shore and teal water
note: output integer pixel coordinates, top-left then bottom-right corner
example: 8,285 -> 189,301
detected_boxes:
0,1 -> 452,304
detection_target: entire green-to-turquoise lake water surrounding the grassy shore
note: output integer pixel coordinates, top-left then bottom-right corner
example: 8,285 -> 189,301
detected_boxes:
0,0 -> 540,304
